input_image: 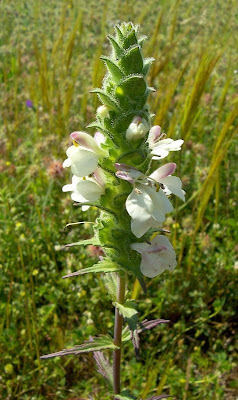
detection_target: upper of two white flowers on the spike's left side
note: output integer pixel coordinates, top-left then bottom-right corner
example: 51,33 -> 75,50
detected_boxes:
63,132 -> 107,177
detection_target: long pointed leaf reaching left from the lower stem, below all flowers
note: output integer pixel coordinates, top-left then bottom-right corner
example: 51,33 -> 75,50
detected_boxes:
40,335 -> 119,359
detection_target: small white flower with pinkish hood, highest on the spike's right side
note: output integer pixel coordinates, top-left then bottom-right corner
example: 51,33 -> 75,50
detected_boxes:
147,125 -> 183,160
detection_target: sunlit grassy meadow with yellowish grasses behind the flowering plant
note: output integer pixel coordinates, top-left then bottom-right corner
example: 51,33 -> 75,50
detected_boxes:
0,0 -> 238,400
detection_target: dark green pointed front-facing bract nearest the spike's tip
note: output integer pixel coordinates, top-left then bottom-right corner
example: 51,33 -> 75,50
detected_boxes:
119,45 -> 143,74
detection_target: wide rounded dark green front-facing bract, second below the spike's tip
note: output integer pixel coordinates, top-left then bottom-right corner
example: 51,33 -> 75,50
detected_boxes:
116,74 -> 146,98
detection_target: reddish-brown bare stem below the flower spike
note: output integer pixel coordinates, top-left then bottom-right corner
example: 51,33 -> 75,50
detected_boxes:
113,273 -> 126,394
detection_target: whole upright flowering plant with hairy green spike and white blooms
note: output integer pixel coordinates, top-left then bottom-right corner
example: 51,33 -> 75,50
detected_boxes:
42,23 -> 185,400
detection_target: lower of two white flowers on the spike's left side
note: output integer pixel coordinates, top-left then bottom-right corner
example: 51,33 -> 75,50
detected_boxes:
62,168 -> 105,211
